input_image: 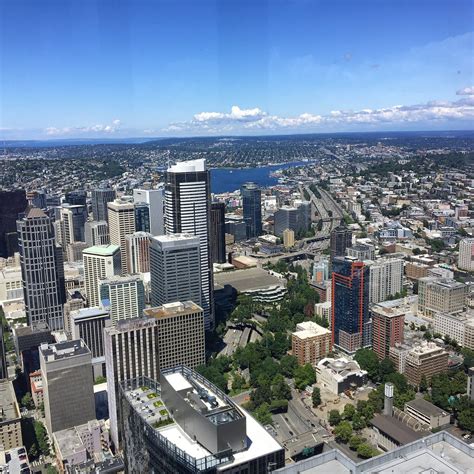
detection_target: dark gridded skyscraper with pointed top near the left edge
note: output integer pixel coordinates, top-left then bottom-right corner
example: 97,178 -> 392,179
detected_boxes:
17,207 -> 66,330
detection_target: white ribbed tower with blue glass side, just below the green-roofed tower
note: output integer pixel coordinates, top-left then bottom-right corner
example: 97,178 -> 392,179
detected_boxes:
99,275 -> 145,323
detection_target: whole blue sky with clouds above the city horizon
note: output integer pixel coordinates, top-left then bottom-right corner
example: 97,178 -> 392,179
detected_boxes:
0,0 -> 474,139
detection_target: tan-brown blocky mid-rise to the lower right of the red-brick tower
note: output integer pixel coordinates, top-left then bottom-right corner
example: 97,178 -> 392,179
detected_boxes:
405,342 -> 448,387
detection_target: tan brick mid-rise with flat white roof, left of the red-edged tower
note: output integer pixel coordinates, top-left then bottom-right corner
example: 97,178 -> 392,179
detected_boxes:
291,321 -> 332,365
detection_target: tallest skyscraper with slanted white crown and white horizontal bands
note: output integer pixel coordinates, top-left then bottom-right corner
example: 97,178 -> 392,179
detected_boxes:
165,159 -> 214,329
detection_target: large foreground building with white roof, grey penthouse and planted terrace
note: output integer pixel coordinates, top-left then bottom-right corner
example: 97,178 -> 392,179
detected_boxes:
119,367 -> 285,474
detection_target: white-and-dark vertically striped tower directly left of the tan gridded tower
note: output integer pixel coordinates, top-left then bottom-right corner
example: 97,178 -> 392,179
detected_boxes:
104,318 -> 159,449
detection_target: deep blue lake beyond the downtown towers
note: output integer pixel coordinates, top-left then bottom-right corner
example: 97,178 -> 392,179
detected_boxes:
211,161 -> 310,194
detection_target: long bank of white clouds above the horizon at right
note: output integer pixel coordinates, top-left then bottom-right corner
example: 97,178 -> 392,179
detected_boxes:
163,94 -> 474,134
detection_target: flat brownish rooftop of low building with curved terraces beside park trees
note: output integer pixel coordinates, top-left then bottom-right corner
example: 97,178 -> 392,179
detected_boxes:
214,268 -> 286,293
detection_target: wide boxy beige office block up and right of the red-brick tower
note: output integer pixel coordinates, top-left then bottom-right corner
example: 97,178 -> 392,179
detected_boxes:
418,277 -> 468,318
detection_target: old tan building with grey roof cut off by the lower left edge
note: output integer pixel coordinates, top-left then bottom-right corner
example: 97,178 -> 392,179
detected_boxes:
0,380 -> 23,451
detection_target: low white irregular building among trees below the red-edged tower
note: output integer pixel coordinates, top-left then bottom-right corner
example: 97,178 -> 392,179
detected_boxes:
315,358 -> 367,395
